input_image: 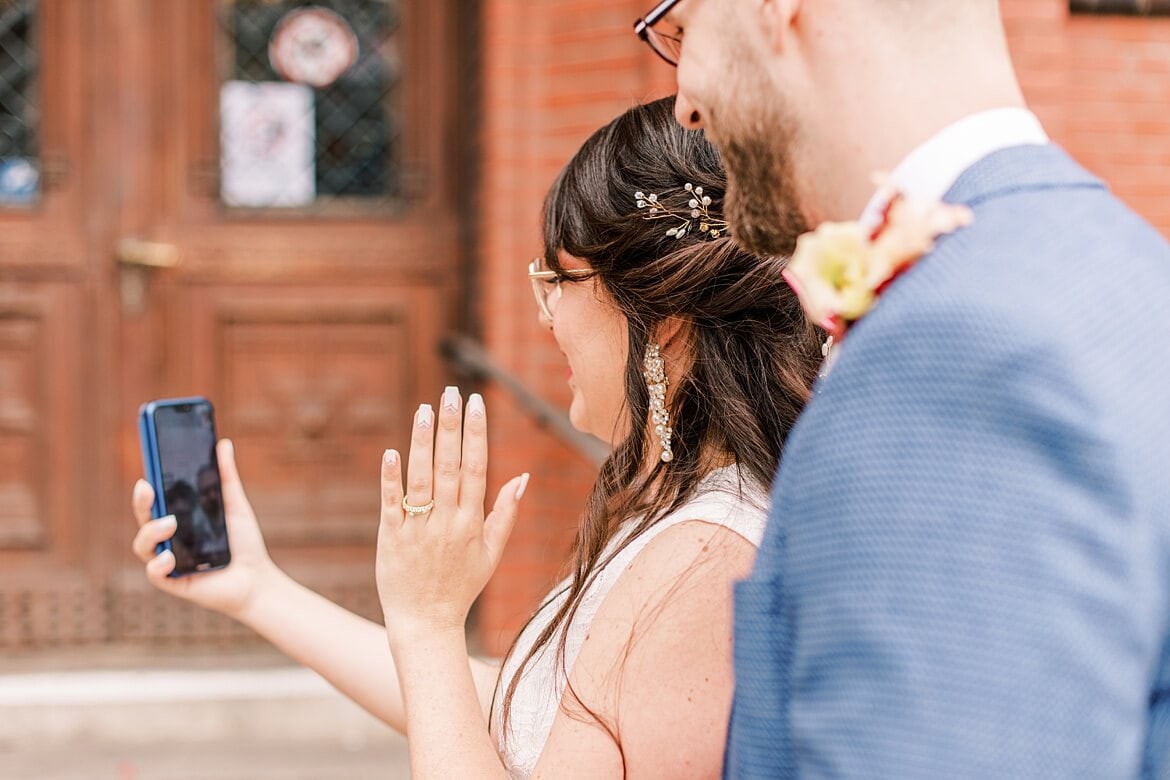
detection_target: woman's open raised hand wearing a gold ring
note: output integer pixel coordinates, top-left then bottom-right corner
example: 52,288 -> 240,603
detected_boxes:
377,387 -> 528,637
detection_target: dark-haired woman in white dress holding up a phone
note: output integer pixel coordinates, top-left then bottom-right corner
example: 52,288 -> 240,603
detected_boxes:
132,99 -> 820,778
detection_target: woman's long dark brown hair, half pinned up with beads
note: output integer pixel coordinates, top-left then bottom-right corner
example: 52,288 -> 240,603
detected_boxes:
501,98 -> 820,746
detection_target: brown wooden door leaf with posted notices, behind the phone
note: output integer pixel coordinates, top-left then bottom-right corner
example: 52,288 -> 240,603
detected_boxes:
107,0 -> 461,640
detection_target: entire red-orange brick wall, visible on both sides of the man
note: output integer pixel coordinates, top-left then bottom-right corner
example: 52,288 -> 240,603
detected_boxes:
479,0 -> 1170,653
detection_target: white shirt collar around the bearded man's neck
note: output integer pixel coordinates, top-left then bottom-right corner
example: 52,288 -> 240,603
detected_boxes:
861,108 -> 1048,227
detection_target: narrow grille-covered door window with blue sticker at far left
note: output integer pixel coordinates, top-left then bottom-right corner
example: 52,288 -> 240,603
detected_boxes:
0,0 -> 40,208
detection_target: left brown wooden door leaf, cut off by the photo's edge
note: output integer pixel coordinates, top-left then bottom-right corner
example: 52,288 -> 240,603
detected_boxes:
0,0 -> 107,647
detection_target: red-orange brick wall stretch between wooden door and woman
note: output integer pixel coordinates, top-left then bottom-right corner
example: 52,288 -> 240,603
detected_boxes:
467,0 -> 673,651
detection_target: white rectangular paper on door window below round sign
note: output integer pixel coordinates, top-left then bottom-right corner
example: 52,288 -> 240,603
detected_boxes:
220,81 -> 317,208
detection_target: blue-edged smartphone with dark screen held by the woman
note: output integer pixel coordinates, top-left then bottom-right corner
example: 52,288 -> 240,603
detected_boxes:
138,396 -> 232,577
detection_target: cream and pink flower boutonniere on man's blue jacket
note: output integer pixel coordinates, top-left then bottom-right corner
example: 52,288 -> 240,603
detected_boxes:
784,193 -> 973,358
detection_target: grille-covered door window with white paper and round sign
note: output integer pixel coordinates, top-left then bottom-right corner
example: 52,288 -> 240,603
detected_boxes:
218,0 -> 402,210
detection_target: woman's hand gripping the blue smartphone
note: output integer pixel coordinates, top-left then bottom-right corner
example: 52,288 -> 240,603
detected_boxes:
130,439 -> 275,619
